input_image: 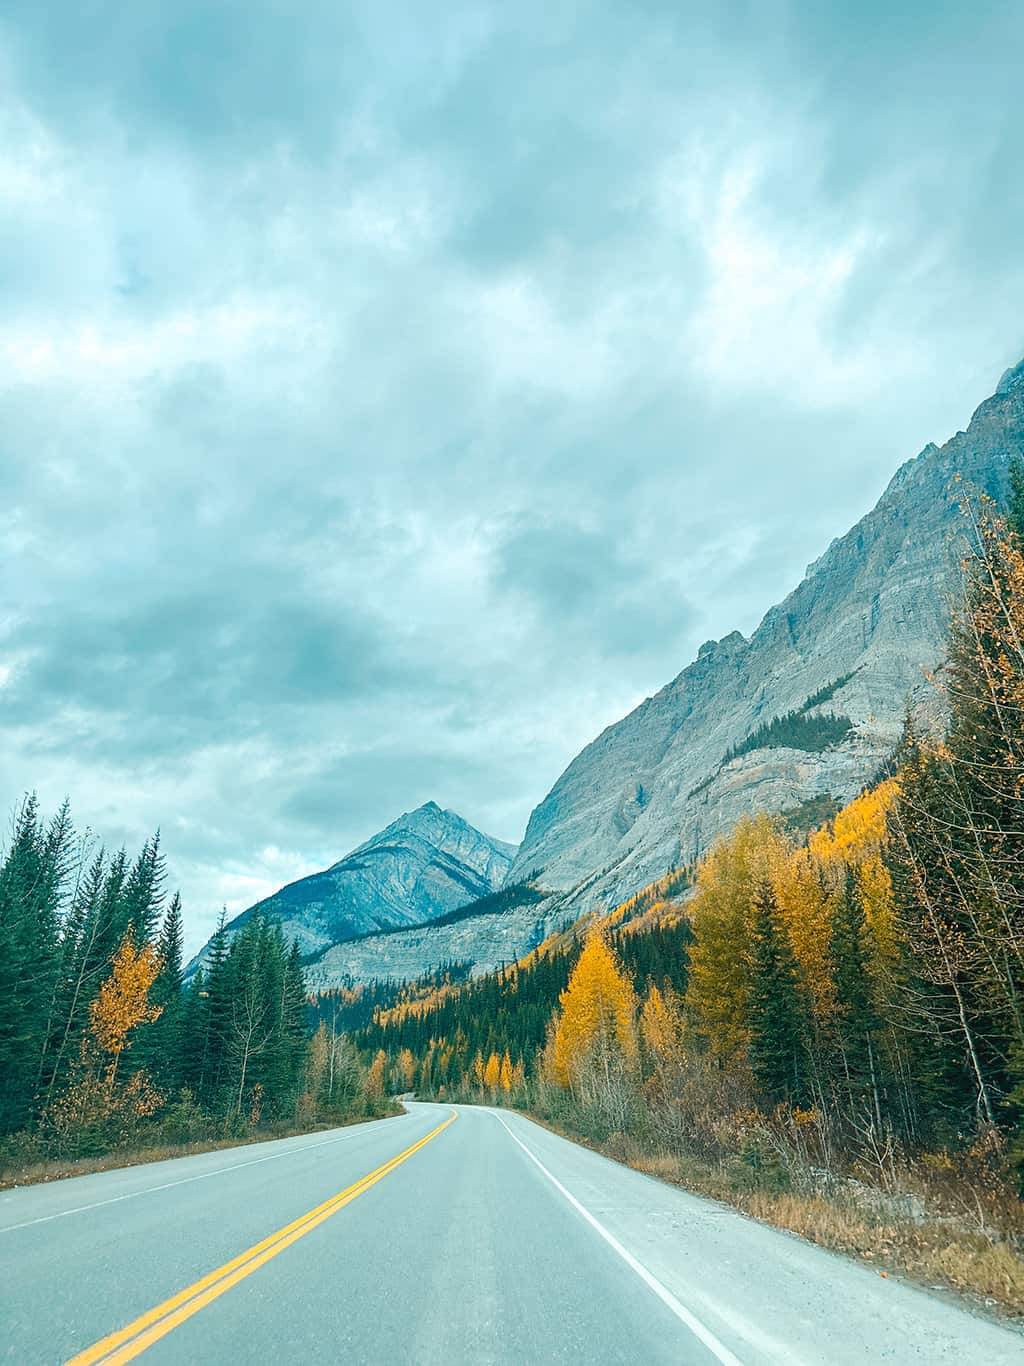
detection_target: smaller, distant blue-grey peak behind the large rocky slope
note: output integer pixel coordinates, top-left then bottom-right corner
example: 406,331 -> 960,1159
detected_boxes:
190,802 -> 516,967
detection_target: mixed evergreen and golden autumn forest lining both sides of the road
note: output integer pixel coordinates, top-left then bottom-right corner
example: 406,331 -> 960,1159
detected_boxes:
0,464 -> 1024,1309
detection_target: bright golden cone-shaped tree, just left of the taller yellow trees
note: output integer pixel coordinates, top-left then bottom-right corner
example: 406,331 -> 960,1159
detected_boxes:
553,932 -> 636,1086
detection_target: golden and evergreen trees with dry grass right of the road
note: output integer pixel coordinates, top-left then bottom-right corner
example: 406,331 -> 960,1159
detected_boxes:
356,478 -> 1024,1314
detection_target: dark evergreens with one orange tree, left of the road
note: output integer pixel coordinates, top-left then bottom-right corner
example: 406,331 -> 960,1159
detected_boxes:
0,814 -> 395,1184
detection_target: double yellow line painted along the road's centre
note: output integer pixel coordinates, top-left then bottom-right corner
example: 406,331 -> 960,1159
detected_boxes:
66,1111 -> 459,1366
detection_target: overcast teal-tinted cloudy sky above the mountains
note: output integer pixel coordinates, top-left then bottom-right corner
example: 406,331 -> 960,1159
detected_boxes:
0,0 -> 1024,949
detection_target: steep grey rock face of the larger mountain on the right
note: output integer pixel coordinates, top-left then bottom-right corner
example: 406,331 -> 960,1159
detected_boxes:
508,362 -> 1024,900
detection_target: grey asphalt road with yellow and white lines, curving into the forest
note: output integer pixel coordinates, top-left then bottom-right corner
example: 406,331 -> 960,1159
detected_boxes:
0,1105 -> 1024,1366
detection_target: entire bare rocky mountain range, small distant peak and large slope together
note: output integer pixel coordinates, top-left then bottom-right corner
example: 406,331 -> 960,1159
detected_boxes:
210,362 -> 1024,989
